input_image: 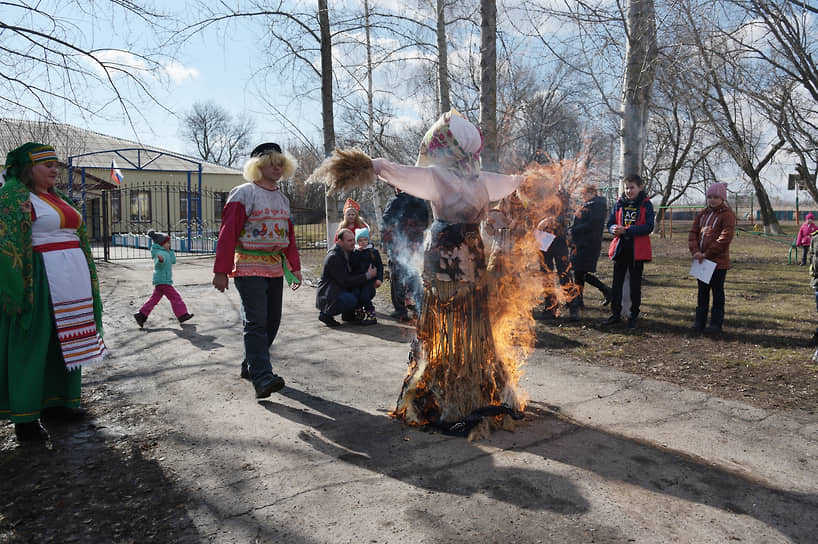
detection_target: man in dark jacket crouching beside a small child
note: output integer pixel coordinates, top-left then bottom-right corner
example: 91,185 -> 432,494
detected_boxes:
315,228 -> 378,327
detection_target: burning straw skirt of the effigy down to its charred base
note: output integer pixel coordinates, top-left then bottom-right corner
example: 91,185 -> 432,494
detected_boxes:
393,280 -> 526,440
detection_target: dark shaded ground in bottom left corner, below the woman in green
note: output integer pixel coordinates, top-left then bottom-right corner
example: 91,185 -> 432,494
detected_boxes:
0,400 -> 202,544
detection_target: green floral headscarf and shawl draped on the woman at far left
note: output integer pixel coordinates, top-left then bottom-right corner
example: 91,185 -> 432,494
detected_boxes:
0,142 -> 102,335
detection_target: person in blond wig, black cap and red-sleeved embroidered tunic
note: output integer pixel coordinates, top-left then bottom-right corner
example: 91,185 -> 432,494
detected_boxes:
213,142 -> 303,399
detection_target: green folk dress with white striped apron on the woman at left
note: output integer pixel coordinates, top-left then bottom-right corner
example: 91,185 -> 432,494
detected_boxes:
0,179 -> 107,423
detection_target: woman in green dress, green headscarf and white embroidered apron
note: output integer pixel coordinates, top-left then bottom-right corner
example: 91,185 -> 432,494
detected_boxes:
0,143 -> 107,441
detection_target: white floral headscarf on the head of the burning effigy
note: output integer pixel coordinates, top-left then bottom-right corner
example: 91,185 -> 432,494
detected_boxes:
415,110 -> 483,177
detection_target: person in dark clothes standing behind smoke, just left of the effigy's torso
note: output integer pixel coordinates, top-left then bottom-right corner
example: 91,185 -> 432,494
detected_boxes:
381,189 -> 429,321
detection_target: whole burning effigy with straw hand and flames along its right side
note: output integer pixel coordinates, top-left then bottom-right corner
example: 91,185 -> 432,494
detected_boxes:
312,110 -> 584,440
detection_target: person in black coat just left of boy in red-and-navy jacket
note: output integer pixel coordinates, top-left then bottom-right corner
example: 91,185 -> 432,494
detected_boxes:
568,183 -> 611,307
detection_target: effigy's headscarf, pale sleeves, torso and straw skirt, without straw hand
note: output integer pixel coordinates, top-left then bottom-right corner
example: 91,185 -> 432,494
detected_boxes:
372,110 -> 524,434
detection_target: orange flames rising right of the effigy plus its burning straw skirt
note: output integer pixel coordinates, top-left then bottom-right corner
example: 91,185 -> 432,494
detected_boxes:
390,155 -> 585,436
